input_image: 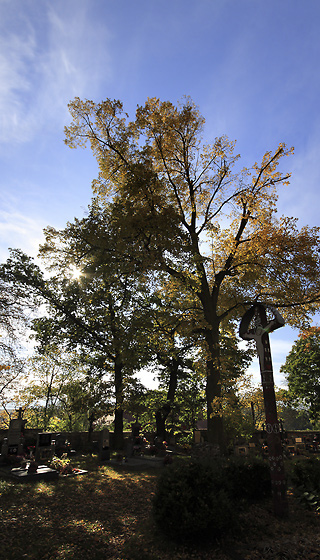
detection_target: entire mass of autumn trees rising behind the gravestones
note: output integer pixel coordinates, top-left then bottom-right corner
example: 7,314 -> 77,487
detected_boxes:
0,98 -> 320,448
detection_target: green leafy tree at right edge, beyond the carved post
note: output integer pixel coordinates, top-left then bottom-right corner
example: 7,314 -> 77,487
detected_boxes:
281,327 -> 320,422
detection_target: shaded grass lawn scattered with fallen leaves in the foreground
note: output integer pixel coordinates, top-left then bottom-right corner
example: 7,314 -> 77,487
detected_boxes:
0,458 -> 320,560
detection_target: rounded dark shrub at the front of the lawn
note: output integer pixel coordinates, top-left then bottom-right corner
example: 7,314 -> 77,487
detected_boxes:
153,463 -> 236,540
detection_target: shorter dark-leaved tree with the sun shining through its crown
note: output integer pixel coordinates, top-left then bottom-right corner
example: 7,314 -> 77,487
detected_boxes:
2,206 -> 152,448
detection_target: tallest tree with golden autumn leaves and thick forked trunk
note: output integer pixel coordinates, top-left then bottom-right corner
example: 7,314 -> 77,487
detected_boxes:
66,98 -> 320,445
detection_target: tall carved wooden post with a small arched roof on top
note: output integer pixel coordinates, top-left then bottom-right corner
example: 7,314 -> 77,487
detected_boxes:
239,303 -> 288,517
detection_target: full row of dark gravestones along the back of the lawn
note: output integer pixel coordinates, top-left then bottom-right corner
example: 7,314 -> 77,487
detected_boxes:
0,400 -> 320,481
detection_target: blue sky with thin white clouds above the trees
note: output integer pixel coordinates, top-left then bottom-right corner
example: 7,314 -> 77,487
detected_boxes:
0,0 -> 320,385
